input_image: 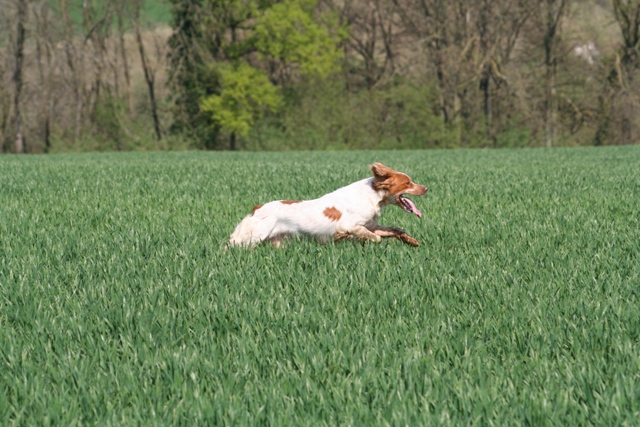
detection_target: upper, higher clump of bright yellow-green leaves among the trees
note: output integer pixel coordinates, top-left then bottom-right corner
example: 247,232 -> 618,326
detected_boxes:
254,0 -> 342,77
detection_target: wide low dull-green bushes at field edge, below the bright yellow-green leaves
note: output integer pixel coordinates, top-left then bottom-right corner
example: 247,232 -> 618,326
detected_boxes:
243,74 -> 456,150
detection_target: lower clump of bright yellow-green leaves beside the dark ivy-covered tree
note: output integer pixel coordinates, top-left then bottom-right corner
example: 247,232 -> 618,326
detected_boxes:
200,62 -> 282,135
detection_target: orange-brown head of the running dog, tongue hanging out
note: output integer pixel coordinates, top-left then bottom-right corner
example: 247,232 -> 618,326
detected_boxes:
371,163 -> 428,218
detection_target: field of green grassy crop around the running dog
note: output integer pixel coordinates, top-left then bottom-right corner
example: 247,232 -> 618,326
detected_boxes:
0,146 -> 640,426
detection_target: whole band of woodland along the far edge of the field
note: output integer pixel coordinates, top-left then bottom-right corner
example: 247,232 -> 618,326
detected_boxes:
0,0 -> 640,152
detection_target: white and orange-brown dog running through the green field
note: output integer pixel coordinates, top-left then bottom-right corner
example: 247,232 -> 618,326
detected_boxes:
229,163 -> 428,251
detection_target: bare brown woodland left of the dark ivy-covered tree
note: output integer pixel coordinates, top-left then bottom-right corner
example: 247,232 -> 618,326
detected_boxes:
0,0 -> 170,153
